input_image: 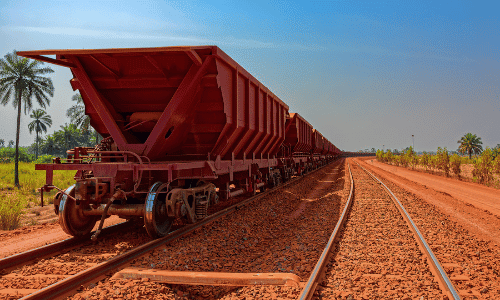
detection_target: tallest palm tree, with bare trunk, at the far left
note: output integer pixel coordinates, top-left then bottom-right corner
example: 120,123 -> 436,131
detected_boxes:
0,50 -> 54,187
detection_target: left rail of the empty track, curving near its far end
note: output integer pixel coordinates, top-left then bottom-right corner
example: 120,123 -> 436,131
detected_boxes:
298,158 -> 354,300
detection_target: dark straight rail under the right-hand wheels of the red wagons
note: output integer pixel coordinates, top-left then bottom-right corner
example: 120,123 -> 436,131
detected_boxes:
21,161 -> 333,300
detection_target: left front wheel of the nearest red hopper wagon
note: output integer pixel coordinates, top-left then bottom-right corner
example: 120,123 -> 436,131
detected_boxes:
59,184 -> 98,236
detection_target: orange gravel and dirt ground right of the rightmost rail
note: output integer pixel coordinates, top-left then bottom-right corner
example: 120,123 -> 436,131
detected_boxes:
359,159 -> 500,299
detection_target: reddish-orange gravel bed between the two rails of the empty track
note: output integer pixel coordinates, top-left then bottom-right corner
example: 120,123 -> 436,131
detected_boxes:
316,164 -> 443,299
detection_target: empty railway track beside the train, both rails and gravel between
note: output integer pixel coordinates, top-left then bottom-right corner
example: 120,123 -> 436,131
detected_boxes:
299,158 -> 460,299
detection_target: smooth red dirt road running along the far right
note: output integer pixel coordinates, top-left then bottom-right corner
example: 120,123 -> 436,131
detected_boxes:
356,157 -> 500,245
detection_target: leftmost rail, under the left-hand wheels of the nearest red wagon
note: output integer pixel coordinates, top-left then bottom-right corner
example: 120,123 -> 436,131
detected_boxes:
0,222 -> 130,272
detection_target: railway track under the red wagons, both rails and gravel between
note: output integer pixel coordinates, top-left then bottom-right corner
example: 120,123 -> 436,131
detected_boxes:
0,161 -> 338,299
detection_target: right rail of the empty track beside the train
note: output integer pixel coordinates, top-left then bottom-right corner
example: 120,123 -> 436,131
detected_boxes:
355,161 -> 461,299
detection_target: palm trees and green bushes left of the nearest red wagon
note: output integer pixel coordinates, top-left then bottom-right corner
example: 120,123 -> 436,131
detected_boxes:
0,50 -> 100,187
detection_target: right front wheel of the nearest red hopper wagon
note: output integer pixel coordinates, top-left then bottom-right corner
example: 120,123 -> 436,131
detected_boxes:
144,182 -> 174,239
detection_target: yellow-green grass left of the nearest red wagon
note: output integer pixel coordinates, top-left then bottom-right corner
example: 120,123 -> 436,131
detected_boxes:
0,162 -> 75,230
